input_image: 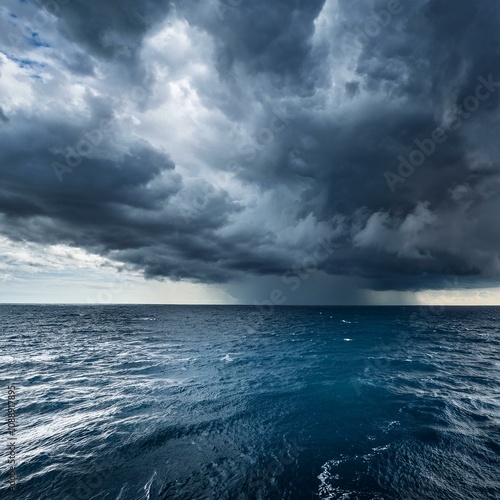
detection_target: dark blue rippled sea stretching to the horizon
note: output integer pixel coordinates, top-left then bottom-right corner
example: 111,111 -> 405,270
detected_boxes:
0,305 -> 500,500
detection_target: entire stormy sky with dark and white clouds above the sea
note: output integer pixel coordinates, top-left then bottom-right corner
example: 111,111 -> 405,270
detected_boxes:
0,0 -> 500,305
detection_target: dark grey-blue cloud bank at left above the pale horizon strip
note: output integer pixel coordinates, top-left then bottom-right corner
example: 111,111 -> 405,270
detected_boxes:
0,99 -> 246,281
